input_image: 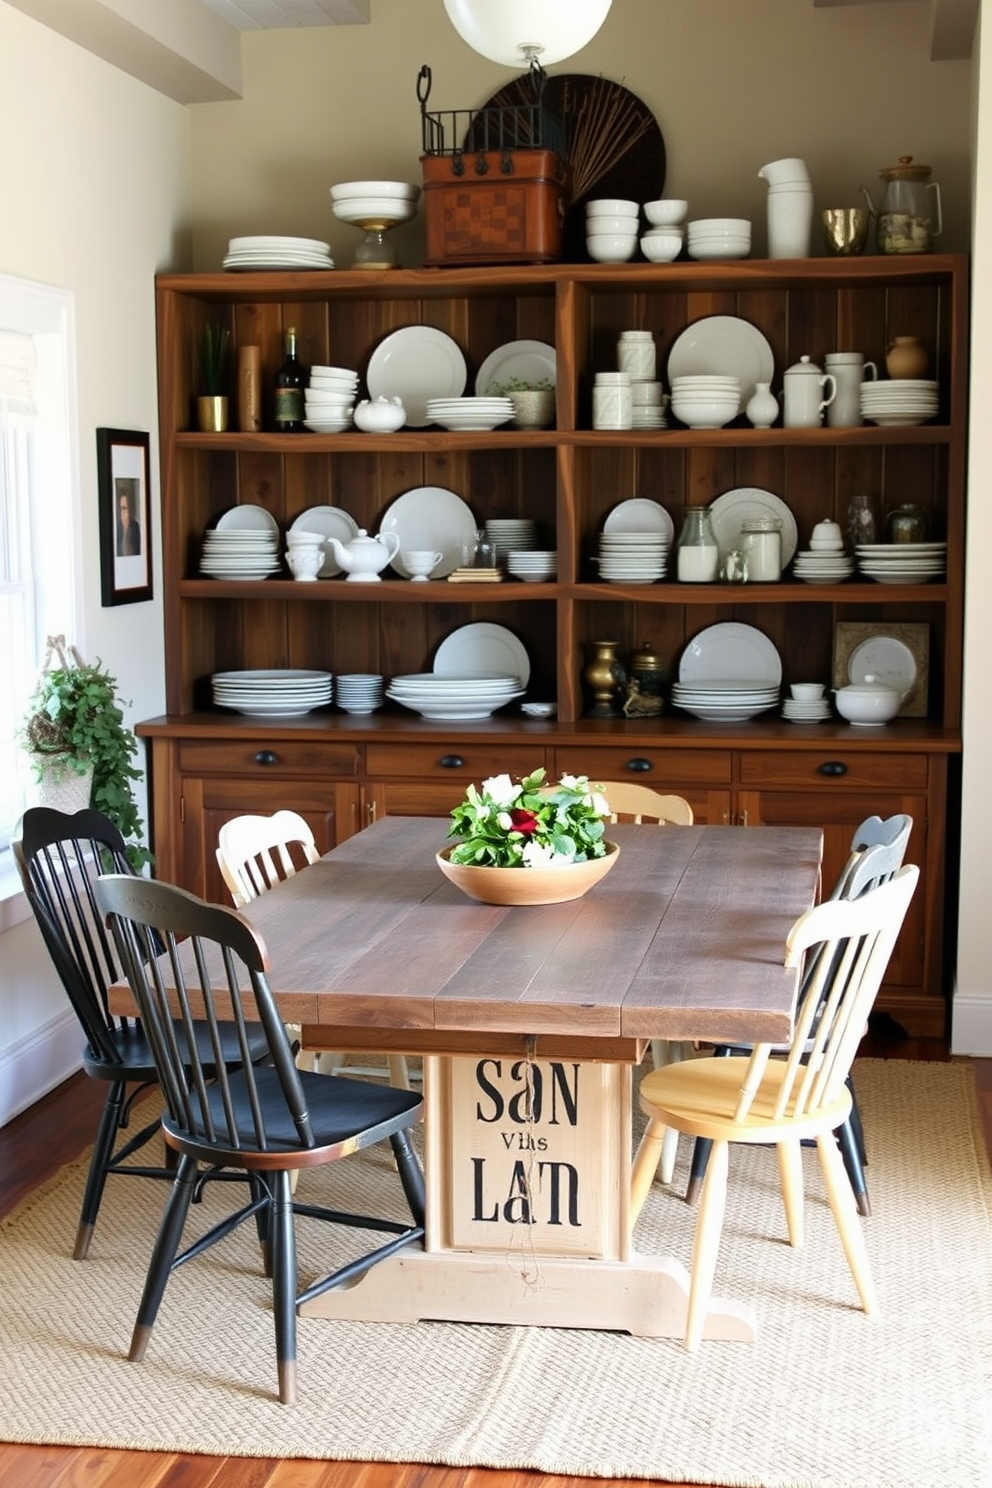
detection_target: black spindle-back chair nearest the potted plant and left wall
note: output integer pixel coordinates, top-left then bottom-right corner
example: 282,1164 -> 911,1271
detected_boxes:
13,806 -> 268,1260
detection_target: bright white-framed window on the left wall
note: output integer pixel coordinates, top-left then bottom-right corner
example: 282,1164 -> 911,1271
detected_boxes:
0,274 -> 77,854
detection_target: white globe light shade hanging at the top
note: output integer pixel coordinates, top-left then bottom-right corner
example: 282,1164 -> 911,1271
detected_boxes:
445,0 -> 613,67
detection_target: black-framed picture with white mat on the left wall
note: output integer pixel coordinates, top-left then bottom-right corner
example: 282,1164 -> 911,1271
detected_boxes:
97,429 -> 152,609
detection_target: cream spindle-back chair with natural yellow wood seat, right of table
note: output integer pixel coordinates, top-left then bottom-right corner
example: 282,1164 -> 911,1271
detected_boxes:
631,866 -> 919,1350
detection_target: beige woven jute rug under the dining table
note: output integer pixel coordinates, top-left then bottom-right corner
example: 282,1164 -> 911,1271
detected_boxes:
0,1061 -> 992,1488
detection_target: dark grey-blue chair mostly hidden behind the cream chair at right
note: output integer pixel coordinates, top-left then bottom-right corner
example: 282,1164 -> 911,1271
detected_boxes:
687,812 -> 913,1219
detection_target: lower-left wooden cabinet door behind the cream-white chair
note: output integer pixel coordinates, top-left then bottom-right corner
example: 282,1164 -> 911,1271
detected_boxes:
180,775 -> 360,905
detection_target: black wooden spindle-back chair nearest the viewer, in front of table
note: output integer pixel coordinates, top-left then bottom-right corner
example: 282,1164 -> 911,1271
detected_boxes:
95,873 -> 424,1405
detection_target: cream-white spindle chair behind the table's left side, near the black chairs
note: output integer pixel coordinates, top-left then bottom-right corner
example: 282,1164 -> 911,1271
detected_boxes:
217,811 -> 410,1091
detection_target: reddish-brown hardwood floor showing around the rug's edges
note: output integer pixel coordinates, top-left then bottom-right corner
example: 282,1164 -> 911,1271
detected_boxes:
0,1027 -> 992,1488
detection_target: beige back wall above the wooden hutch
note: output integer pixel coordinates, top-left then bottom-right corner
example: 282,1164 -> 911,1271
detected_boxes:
190,0 -> 971,269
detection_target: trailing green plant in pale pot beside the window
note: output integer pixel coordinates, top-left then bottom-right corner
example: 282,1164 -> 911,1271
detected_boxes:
19,635 -> 152,869
